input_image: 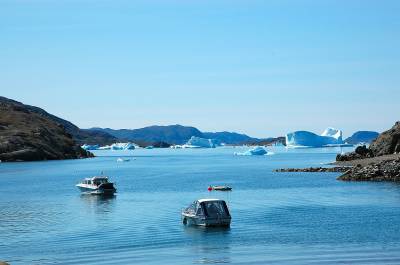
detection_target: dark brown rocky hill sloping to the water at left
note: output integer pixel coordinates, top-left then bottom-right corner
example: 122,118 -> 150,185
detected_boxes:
0,97 -> 92,161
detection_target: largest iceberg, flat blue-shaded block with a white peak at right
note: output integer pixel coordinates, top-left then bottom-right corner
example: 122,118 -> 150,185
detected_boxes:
286,128 -> 345,148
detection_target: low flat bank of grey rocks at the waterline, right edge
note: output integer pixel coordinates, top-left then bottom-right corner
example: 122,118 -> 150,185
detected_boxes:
338,158 -> 400,181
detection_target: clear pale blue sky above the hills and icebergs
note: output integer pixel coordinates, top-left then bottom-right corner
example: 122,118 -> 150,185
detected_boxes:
0,0 -> 400,137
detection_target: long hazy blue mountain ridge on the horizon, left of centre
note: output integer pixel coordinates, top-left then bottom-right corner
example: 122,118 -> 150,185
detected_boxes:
87,125 -> 260,144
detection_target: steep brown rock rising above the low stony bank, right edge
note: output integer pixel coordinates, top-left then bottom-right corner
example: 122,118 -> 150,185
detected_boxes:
369,121 -> 400,156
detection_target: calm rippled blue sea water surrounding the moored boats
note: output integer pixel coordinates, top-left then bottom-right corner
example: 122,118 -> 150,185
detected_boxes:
0,148 -> 400,265
